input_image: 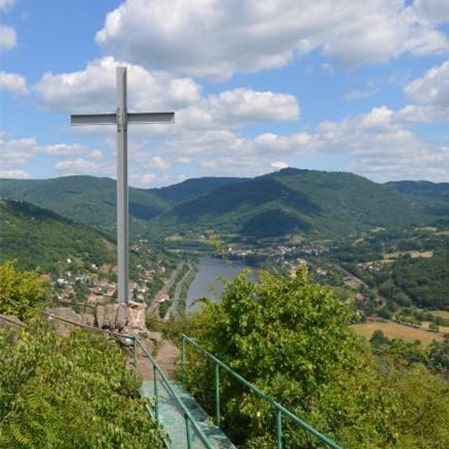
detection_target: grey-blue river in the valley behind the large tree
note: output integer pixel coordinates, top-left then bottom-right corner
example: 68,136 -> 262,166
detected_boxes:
186,256 -> 256,313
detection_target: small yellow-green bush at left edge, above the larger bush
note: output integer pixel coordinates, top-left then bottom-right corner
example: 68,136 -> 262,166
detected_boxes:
0,262 -> 45,320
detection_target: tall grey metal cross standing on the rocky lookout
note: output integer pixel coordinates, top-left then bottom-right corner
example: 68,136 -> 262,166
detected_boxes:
70,67 -> 175,303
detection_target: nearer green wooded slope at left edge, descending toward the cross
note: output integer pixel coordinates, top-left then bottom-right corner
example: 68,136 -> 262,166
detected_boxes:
0,198 -> 115,272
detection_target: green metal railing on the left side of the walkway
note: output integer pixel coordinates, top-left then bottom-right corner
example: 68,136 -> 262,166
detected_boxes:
128,335 -> 214,449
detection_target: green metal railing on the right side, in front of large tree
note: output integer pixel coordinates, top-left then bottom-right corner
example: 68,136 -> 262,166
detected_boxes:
181,334 -> 342,449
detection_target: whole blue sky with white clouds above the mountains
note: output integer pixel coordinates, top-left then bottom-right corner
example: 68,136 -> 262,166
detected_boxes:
0,0 -> 449,188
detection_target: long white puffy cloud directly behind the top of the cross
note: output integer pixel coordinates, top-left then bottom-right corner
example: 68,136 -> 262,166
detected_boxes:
33,57 -> 300,136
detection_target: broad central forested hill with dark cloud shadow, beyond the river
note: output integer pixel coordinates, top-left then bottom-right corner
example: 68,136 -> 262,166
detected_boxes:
153,168 -> 439,238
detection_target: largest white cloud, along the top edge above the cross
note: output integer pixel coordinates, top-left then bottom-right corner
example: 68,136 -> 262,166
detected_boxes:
96,0 -> 449,78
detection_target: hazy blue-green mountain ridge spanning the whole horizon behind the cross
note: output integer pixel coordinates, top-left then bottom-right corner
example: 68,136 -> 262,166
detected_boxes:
0,168 -> 449,239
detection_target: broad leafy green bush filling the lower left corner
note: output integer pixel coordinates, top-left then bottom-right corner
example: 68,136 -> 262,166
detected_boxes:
0,322 -> 162,449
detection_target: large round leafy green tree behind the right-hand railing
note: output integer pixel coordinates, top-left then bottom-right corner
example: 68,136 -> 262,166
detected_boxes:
182,268 -> 396,449
